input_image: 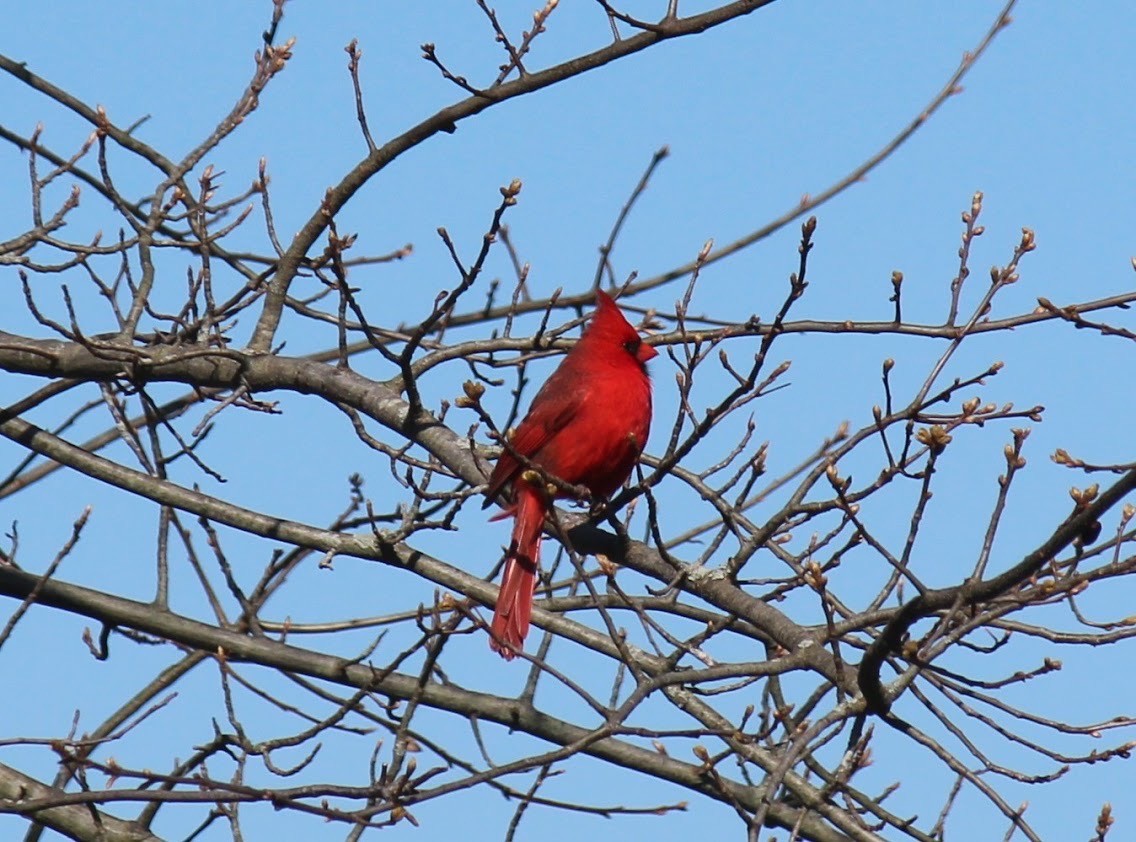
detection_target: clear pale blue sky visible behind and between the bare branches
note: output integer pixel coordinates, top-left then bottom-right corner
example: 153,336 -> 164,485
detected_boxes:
0,0 -> 1136,842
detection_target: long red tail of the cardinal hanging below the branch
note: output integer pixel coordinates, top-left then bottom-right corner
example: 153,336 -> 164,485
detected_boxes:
490,482 -> 546,660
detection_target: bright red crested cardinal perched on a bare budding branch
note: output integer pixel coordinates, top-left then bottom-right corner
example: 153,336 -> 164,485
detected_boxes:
485,290 -> 659,660
